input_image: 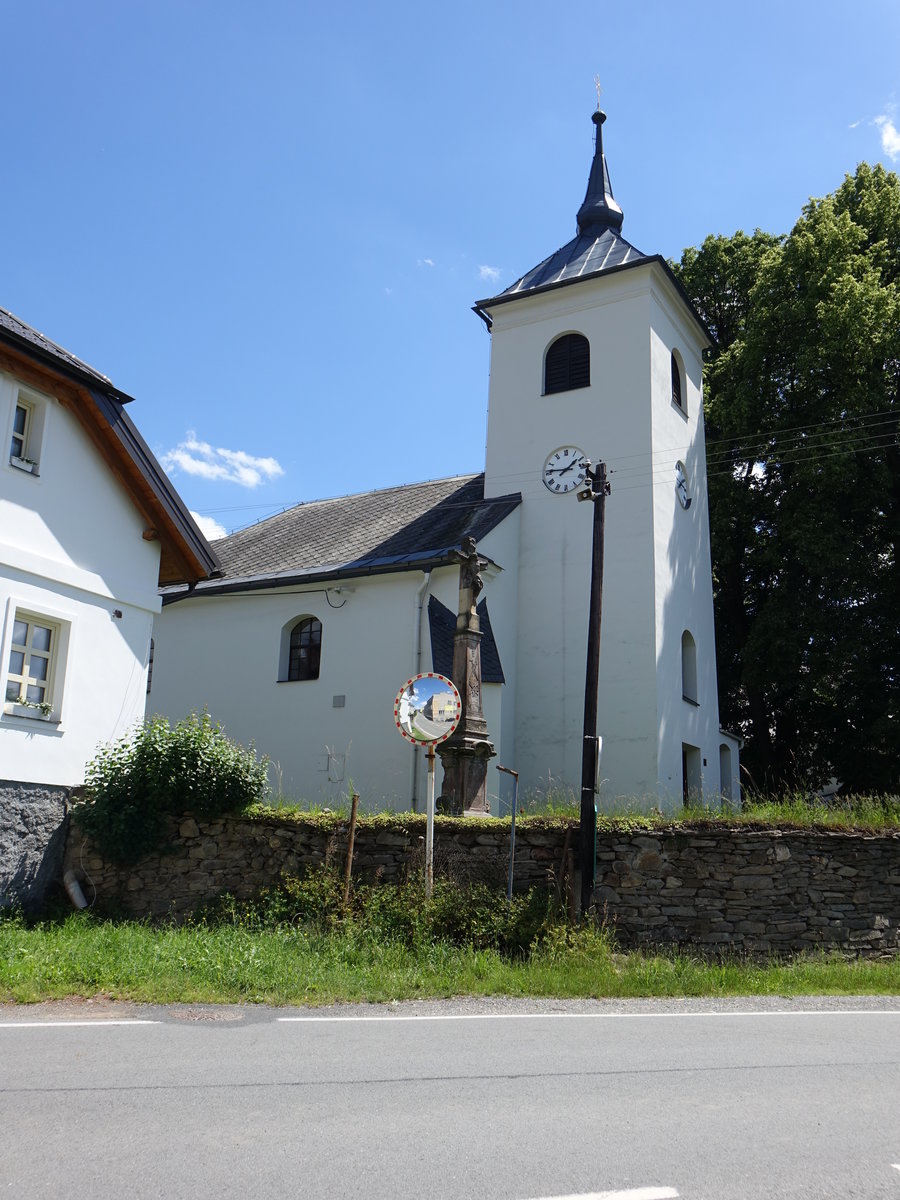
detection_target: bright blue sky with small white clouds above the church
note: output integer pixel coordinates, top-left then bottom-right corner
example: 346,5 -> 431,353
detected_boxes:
0,0 -> 900,530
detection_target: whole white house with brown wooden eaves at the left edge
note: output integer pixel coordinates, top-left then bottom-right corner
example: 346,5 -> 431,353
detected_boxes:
0,308 -> 218,899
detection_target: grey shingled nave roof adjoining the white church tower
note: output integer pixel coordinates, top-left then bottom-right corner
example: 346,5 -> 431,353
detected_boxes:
163,474 -> 521,604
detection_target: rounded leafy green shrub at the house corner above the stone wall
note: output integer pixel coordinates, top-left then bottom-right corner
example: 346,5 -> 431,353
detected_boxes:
72,713 -> 268,864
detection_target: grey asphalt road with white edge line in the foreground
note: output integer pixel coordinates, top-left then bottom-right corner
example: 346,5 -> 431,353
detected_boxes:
0,997 -> 900,1200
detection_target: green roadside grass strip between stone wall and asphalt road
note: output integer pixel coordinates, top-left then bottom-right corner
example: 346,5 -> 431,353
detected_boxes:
0,901 -> 900,1004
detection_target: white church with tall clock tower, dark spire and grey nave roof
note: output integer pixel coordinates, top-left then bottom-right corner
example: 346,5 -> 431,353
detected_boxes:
150,113 -> 738,810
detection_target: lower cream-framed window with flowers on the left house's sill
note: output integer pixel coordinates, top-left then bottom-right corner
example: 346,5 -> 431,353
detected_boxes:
0,599 -> 71,725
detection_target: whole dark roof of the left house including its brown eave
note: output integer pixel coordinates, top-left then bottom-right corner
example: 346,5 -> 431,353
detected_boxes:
0,308 -> 220,584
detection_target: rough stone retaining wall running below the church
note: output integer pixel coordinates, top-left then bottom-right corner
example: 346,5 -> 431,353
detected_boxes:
66,815 -> 900,954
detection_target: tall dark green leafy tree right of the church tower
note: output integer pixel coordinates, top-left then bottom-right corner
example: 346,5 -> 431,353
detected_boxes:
676,164 -> 900,791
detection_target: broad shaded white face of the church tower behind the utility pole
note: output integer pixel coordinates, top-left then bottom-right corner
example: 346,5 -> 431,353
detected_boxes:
486,270 -> 672,798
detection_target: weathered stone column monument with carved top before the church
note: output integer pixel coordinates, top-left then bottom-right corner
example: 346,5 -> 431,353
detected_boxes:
437,538 -> 497,816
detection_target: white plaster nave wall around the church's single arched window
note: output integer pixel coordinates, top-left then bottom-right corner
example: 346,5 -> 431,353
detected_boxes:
154,568 -> 513,810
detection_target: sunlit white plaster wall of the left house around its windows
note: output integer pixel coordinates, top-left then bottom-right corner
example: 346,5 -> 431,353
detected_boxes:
0,374 -> 160,786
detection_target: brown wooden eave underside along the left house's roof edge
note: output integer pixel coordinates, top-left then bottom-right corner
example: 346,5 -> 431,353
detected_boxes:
0,342 -> 222,587
